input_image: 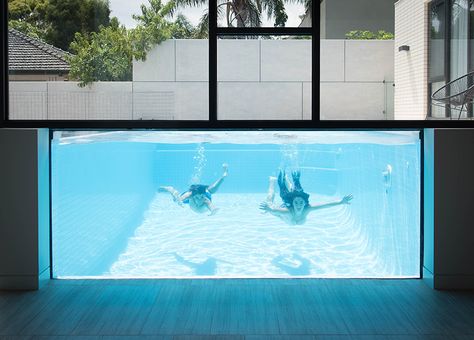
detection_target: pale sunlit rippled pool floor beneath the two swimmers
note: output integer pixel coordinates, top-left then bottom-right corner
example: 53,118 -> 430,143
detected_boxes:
105,194 -> 384,277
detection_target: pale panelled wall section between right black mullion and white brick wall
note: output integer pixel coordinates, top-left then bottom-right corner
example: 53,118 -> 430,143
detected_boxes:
320,40 -> 394,120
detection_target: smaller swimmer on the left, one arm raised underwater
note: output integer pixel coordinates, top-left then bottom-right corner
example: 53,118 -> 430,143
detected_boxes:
159,163 -> 228,215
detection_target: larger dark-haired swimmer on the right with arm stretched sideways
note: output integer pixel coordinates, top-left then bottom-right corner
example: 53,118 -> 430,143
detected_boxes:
260,171 -> 353,225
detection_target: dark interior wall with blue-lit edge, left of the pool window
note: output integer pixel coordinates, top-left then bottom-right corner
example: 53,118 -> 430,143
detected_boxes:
0,129 -> 50,289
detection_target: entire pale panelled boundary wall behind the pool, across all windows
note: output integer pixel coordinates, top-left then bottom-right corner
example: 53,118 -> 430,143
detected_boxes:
10,39 -> 393,120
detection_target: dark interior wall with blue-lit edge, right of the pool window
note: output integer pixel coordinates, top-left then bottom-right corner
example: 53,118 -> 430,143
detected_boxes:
424,129 -> 474,289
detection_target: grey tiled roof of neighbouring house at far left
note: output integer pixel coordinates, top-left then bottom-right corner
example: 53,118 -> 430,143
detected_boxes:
8,29 -> 70,81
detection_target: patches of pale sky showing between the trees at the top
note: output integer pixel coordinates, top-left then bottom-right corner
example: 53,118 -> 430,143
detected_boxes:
109,0 -> 304,28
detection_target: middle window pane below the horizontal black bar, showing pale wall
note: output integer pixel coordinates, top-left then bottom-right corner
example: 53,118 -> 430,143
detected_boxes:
217,36 -> 311,120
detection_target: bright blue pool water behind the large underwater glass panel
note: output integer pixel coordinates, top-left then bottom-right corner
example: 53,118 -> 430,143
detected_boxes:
52,131 -> 420,278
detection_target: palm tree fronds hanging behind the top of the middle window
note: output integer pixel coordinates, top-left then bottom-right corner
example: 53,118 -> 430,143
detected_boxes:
174,0 -> 312,27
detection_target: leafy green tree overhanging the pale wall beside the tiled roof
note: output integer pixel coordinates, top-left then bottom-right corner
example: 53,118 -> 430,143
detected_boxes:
69,0 -> 191,86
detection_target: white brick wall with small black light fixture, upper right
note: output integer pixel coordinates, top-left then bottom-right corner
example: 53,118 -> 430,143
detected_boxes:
395,0 -> 428,120
